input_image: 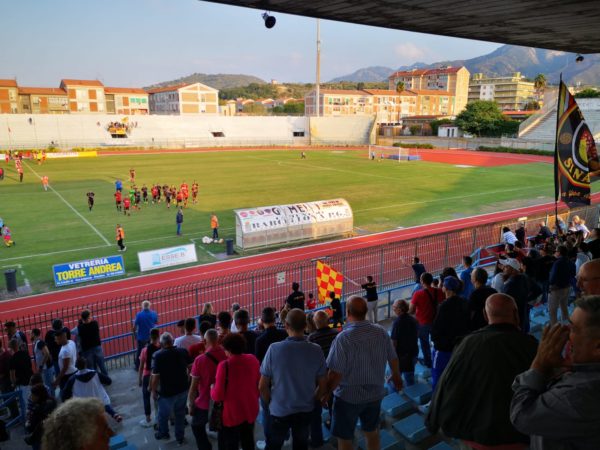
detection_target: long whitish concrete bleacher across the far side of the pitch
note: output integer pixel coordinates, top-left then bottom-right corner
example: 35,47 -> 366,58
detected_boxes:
0,114 -> 374,149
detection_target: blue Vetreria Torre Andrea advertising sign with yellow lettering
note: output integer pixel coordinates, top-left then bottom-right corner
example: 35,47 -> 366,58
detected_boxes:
52,255 -> 125,286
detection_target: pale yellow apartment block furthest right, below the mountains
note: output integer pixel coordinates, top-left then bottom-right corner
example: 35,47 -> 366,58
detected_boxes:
469,72 -> 535,111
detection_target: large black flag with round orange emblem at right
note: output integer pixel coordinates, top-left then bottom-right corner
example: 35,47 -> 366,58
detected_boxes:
554,77 -> 600,207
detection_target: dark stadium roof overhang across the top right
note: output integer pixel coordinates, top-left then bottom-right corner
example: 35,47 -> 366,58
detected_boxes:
200,0 -> 600,53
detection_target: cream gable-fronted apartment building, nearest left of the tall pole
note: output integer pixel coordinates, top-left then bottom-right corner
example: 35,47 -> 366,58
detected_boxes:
147,83 -> 219,114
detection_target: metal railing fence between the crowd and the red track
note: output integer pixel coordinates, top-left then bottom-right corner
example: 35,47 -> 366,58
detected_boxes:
4,206 -> 598,366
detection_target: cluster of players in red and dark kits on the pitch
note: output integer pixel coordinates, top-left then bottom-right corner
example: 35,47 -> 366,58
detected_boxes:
108,169 -> 198,216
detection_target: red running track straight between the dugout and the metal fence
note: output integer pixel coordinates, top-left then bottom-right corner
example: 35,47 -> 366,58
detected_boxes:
0,193 -> 600,321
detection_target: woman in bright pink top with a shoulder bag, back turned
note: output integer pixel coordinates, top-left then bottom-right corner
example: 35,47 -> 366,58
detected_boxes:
210,333 -> 260,450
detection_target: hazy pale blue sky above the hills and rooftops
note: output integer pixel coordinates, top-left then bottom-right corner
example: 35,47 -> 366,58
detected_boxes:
0,0 -> 499,87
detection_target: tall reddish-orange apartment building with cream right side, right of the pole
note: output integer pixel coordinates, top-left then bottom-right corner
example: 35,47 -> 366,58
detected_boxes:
388,66 -> 470,115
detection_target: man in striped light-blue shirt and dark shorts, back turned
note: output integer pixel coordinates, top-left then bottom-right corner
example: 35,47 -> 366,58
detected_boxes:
327,296 -> 402,450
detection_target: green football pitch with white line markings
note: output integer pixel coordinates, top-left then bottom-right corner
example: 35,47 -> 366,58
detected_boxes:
0,150 -> 553,292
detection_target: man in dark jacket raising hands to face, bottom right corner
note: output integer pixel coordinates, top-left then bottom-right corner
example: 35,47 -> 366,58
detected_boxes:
510,296 -> 600,450
